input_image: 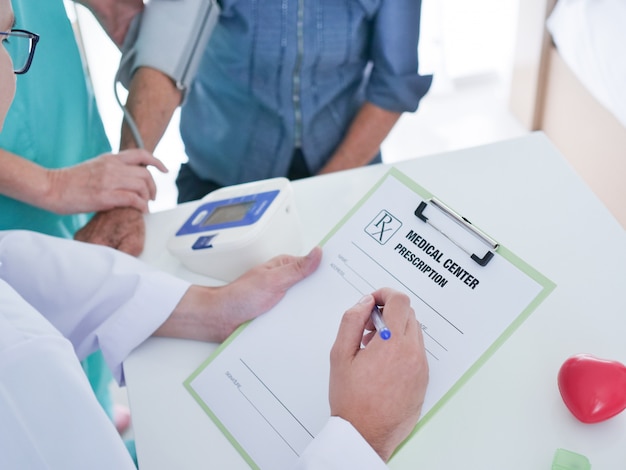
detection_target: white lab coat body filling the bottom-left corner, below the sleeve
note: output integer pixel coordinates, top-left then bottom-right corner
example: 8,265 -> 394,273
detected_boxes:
0,279 -> 135,470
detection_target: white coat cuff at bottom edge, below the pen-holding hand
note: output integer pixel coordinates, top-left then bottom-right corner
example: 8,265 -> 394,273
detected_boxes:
296,417 -> 387,470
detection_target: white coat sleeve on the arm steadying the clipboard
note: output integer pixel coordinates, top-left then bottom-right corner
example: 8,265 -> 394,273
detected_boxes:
0,230 -> 189,383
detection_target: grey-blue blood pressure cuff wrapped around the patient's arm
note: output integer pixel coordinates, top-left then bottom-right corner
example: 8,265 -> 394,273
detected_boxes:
117,0 -> 219,98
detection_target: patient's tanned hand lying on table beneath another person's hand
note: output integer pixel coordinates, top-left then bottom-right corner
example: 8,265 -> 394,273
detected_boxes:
74,207 -> 146,256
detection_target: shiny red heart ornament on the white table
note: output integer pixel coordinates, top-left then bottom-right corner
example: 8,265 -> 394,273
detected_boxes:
558,354 -> 626,423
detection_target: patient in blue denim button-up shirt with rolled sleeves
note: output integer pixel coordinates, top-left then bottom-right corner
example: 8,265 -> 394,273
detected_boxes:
77,0 -> 432,258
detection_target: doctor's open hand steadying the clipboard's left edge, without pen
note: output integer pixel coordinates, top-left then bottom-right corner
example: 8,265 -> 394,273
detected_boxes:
155,247 -> 322,342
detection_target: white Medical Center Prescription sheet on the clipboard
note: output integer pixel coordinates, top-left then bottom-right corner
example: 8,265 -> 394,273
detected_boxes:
189,173 -> 544,469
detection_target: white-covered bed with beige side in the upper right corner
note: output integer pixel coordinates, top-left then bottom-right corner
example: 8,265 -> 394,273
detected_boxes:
511,0 -> 626,228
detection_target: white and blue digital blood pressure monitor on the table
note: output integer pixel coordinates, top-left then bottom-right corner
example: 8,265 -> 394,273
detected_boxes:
167,178 -> 302,281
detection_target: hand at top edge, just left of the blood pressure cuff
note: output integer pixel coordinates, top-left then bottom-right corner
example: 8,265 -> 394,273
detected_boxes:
74,0 -> 143,47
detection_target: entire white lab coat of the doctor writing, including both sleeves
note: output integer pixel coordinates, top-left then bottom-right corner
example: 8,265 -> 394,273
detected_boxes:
0,231 -> 386,470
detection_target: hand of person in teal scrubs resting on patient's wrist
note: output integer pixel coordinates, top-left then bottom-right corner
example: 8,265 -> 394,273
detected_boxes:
41,149 -> 167,214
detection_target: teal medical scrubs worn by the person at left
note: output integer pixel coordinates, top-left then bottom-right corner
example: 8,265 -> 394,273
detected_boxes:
0,0 -> 113,434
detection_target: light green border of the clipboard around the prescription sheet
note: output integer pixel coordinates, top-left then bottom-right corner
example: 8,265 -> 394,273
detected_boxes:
184,167 -> 556,469
